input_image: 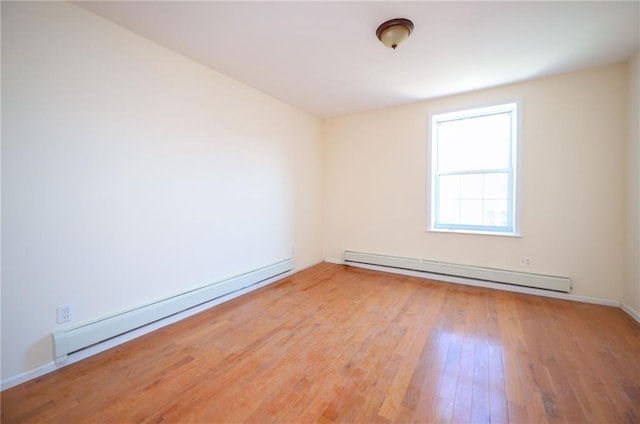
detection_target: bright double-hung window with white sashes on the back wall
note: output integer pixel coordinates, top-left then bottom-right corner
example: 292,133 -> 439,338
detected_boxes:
429,102 -> 519,235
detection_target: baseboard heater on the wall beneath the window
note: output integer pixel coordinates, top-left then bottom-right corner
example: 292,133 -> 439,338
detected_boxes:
344,250 -> 571,293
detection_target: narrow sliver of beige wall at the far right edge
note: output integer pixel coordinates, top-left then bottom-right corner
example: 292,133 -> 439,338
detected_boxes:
623,52 -> 640,316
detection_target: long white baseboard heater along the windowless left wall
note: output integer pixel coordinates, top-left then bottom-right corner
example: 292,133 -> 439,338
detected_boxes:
53,259 -> 294,362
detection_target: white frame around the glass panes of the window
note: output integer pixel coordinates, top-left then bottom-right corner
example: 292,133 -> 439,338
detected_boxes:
427,99 -> 522,237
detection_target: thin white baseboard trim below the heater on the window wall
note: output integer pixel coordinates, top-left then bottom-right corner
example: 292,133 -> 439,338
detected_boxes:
325,259 -> 620,308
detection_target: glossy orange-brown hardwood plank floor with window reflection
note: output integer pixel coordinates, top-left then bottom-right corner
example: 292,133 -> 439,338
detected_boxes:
1,264 -> 640,423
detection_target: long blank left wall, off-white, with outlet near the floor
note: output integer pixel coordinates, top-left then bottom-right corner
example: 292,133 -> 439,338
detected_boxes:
2,2 -> 322,379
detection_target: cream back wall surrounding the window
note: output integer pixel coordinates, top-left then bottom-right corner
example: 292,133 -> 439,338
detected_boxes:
324,64 -> 627,300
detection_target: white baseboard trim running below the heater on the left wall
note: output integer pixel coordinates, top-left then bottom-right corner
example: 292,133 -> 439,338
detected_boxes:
0,260 -> 324,391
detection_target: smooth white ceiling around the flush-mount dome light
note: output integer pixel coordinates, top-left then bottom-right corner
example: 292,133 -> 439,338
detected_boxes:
75,1 -> 640,117
